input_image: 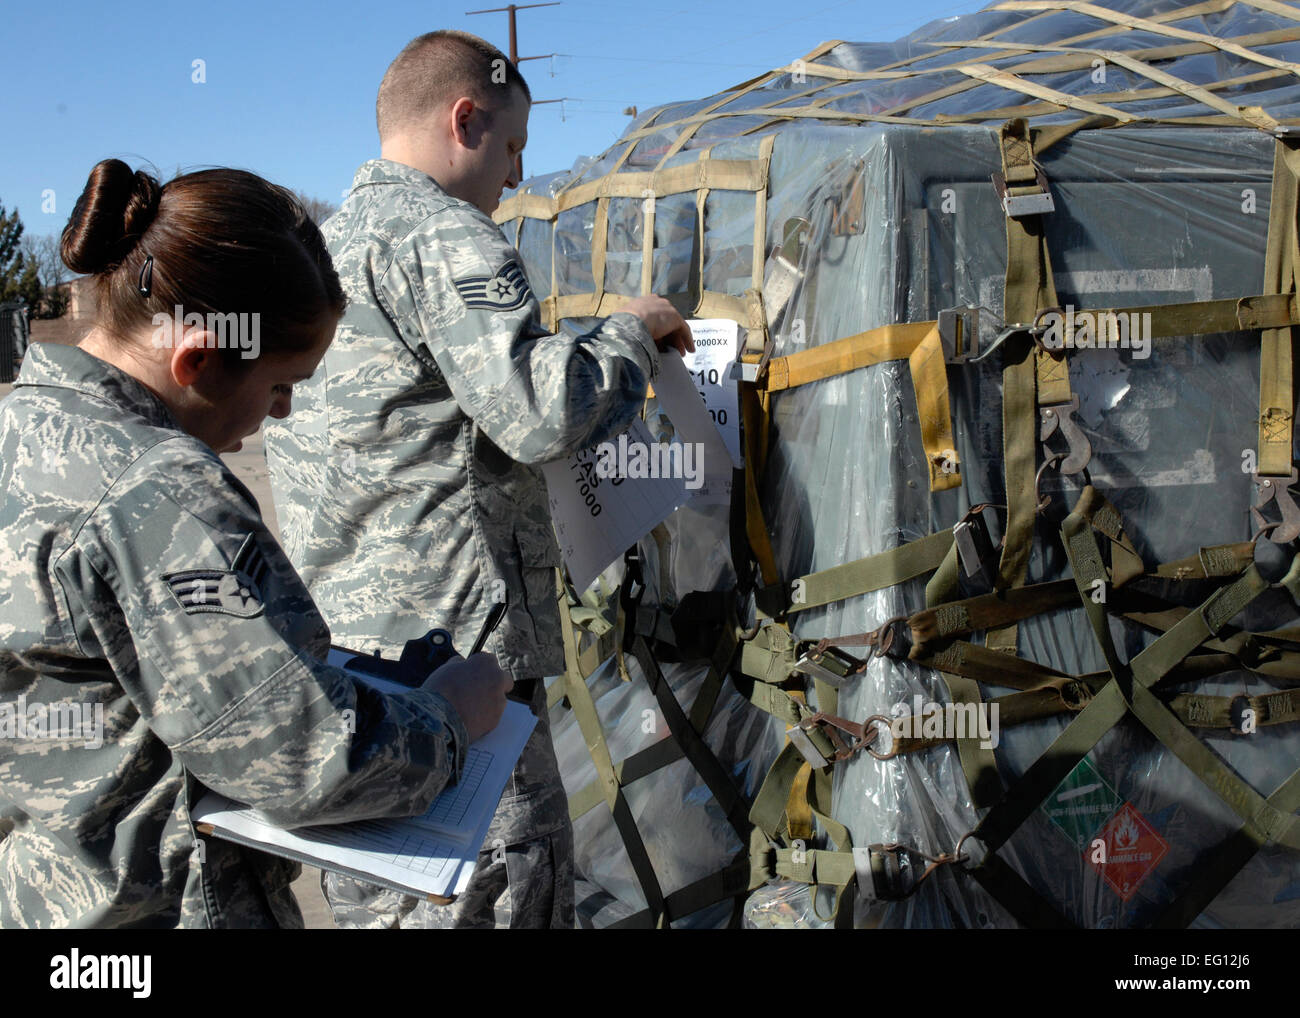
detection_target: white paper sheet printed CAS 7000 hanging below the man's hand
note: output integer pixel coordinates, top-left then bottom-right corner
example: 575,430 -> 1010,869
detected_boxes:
542,417 -> 693,590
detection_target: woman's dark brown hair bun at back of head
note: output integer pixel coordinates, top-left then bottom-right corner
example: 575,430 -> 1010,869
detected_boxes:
60,159 -> 163,274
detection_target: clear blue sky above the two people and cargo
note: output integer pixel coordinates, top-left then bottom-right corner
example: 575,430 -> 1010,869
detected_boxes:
0,0 -> 984,243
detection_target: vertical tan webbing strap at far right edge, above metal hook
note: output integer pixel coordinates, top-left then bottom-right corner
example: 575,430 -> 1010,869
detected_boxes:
1257,138 -> 1300,477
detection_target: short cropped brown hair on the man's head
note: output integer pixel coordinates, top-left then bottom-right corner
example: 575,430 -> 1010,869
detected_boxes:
374,29 -> 533,140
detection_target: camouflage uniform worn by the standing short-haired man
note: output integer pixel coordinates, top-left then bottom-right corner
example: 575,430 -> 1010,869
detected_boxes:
267,160 -> 659,927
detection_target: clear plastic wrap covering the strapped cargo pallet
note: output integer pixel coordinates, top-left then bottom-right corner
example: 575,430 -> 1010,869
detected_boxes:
502,3 -> 1300,928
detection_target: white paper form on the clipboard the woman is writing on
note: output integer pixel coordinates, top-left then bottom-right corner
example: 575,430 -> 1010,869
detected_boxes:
194,647 -> 537,897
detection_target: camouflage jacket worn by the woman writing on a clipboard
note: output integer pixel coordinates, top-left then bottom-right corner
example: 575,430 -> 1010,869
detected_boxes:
0,345 -> 467,927
